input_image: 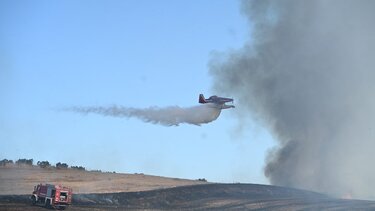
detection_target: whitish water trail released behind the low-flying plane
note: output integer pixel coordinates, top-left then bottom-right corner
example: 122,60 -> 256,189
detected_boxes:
64,103 -> 221,126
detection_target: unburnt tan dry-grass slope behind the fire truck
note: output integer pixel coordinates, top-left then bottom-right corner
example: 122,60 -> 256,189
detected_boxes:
0,166 -> 204,195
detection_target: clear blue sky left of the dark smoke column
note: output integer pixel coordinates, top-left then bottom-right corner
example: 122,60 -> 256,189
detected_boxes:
0,0 -> 274,183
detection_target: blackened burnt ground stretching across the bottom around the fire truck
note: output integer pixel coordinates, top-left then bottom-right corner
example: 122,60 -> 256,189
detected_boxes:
0,184 -> 375,211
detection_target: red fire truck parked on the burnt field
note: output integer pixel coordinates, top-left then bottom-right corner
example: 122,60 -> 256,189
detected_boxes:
31,184 -> 73,209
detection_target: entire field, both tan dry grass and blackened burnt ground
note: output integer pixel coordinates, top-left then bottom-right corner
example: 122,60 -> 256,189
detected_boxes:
0,167 -> 375,211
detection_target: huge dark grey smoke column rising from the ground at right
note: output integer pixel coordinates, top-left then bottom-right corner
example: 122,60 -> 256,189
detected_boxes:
210,0 -> 375,199
